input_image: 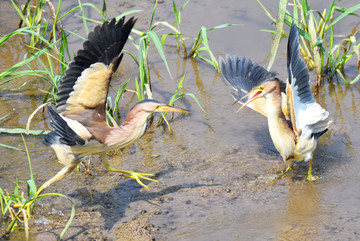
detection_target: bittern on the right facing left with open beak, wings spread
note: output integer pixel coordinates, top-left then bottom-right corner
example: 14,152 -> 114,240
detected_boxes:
220,24 -> 331,180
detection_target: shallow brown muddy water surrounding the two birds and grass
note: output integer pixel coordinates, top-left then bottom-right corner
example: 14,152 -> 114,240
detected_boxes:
0,0 -> 360,240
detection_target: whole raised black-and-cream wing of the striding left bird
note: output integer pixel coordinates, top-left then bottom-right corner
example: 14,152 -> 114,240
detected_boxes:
56,18 -> 136,116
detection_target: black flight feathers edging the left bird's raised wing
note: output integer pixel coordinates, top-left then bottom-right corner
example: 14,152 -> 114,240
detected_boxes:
56,17 -> 136,112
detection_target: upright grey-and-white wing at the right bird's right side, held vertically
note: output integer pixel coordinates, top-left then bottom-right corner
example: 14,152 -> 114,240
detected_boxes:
286,23 -> 331,136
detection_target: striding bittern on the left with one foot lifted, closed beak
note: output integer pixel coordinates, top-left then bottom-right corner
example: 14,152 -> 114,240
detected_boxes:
37,18 -> 187,198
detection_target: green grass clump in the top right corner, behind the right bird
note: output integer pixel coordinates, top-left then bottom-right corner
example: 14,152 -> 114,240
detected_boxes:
257,0 -> 360,86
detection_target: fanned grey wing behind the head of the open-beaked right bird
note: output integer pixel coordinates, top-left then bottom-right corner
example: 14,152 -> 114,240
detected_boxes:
219,55 -> 282,117
